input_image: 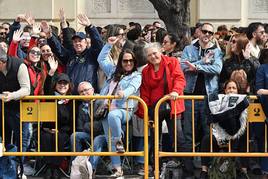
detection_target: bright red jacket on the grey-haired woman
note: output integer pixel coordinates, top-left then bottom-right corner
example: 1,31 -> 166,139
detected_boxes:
137,55 -> 186,118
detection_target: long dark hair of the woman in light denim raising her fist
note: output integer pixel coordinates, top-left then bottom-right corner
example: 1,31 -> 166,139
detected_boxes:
113,49 -> 137,82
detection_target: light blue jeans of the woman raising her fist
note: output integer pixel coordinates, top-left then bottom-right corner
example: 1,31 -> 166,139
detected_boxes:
102,109 -> 133,168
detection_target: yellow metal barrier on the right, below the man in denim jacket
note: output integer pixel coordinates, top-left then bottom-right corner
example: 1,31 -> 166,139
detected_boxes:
154,95 -> 268,179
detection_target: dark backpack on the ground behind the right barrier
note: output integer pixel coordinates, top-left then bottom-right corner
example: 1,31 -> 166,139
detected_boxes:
208,157 -> 236,179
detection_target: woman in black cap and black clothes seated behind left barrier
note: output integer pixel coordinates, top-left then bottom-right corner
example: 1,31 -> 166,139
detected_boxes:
40,73 -> 73,179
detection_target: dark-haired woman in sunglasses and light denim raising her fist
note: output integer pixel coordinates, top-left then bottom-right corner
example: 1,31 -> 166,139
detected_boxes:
98,36 -> 141,177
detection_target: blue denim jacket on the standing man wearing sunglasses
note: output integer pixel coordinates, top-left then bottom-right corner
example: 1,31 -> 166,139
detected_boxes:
181,41 -> 222,94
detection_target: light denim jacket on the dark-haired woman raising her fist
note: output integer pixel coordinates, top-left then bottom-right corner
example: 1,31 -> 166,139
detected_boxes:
98,44 -> 141,109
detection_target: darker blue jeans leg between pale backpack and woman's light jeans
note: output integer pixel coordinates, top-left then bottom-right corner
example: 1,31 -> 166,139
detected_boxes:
90,135 -> 107,170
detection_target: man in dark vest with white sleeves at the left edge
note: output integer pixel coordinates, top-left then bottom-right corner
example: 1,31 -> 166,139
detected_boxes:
0,44 -> 30,151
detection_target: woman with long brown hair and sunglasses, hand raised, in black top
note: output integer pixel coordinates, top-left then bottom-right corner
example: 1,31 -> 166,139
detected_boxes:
220,34 -> 260,94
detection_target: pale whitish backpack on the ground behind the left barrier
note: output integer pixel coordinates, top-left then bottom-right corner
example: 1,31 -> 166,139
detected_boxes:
70,150 -> 93,179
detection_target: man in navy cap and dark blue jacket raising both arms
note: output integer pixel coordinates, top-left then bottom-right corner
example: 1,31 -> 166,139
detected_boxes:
46,14 -> 103,94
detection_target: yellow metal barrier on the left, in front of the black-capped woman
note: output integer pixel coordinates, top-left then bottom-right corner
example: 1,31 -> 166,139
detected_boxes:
2,96 -> 149,178
